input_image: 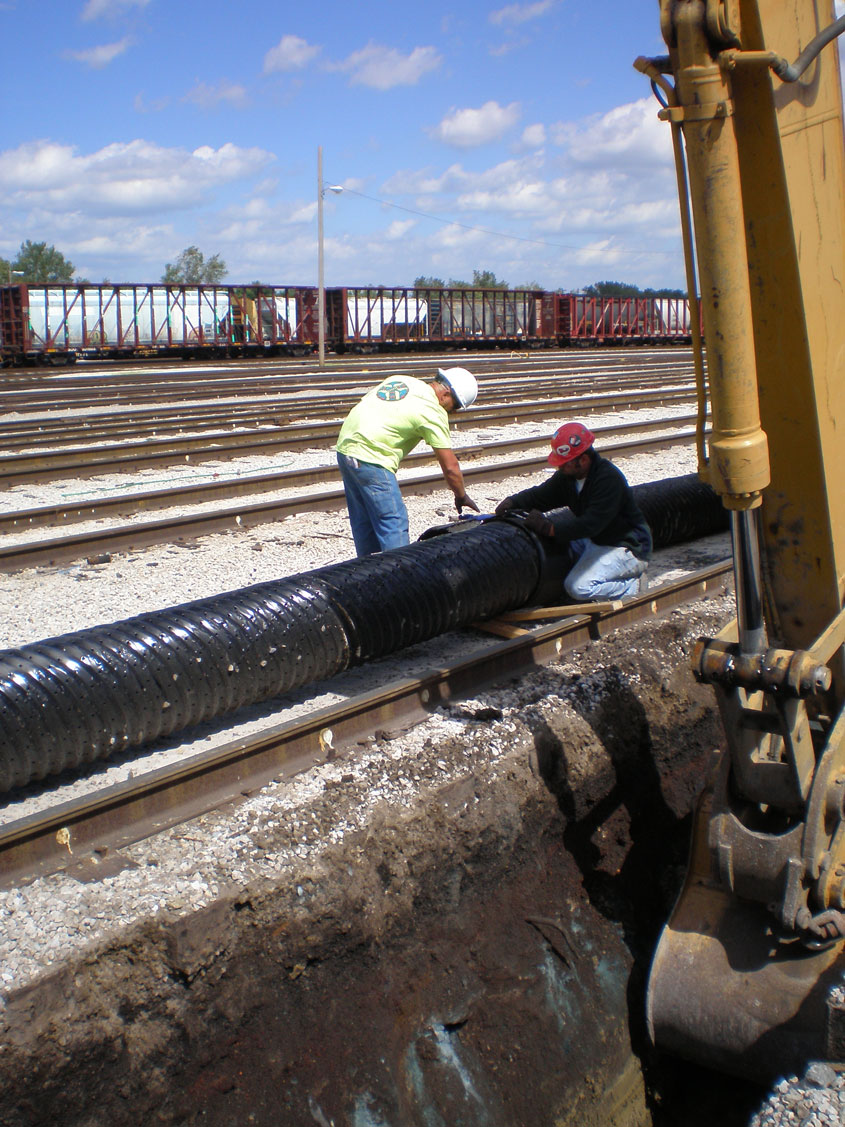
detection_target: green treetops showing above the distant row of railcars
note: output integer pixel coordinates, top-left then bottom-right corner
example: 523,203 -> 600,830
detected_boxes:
0,239 -> 686,298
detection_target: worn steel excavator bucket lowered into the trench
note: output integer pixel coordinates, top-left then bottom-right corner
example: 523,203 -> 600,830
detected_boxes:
647,791 -> 845,1082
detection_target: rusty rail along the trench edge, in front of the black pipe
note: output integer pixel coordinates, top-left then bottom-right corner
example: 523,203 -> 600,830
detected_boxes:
0,560 -> 732,887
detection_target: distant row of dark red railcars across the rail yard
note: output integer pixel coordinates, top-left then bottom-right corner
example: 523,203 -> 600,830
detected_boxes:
0,284 -> 690,365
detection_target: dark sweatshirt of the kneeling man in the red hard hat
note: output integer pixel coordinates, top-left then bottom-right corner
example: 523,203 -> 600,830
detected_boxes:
510,450 -> 651,560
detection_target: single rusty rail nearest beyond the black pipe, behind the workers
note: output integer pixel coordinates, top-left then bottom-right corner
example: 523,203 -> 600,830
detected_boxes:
0,431 -> 695,573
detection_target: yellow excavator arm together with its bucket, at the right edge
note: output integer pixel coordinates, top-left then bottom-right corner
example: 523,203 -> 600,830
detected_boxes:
637,0 -> 845,1076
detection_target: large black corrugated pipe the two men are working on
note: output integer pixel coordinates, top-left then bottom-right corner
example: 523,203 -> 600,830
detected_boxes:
0,474 -> 727,791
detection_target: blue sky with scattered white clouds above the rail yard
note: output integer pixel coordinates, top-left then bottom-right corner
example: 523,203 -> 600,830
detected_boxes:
0,0 -> 684,289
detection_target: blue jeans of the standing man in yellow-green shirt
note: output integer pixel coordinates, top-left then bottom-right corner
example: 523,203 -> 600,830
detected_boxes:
337,452 -> 409,556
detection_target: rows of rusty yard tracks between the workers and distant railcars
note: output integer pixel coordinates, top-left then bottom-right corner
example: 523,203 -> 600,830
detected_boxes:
0,349 -> 695,571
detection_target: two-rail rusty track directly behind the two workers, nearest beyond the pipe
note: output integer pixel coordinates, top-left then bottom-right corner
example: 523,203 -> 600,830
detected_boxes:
0,428 -> 695,571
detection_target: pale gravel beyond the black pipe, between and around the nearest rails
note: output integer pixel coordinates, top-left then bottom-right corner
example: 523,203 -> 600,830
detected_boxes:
0,411 -> 695,648
